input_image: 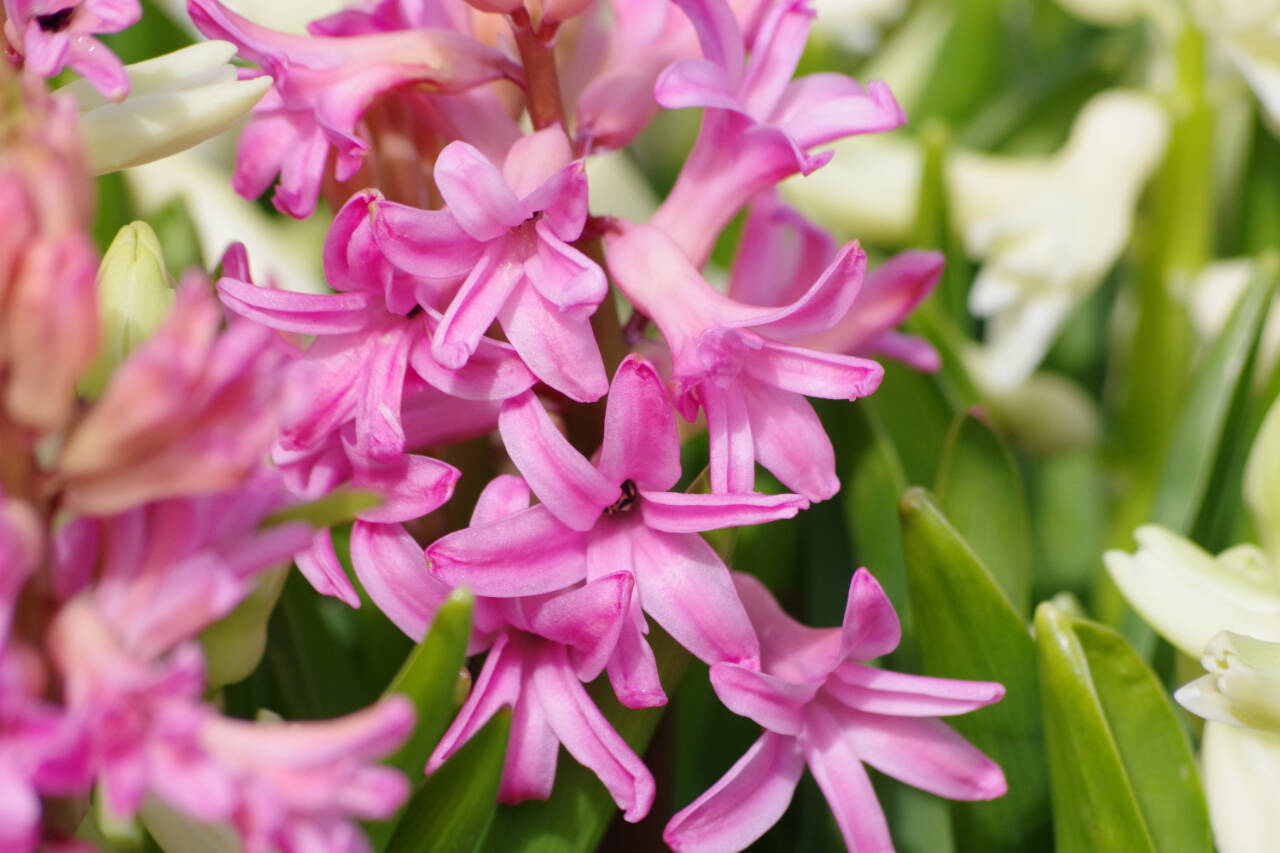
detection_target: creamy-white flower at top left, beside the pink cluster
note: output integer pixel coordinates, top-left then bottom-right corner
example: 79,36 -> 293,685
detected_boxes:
59,41 -> 271,174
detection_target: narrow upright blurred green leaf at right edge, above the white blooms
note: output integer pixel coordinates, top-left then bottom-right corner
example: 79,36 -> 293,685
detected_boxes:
1151,253 -> 1277,534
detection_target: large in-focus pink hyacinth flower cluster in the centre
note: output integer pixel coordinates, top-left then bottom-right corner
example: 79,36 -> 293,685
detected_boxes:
188,0 -> 1005,849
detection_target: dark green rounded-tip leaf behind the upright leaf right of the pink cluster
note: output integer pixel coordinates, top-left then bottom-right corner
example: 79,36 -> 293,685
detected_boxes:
934,415 -> 1032,619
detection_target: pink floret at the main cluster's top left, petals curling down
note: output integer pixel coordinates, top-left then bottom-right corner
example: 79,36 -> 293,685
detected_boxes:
187,0 -> 522,219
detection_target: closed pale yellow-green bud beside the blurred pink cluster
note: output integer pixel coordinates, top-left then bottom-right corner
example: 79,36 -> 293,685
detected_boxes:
79,222 -> 174,398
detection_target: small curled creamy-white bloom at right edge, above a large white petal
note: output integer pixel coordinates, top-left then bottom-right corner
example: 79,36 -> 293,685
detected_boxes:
1174,631 -> 1280,731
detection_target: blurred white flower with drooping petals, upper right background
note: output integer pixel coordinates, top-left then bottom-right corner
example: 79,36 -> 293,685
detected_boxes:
948,91 -> 1169,389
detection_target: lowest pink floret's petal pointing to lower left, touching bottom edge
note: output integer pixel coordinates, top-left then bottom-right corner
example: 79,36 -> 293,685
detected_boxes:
662,731 -> 803,853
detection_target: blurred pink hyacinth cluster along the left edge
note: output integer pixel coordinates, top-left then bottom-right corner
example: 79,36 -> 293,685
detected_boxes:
0,68 -> 413,852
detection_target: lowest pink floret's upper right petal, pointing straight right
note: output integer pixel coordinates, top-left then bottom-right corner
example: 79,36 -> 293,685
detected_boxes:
823,663 -> 1005,717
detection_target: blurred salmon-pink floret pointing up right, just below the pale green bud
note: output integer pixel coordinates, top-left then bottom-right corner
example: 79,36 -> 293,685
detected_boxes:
58,273 -> 291,515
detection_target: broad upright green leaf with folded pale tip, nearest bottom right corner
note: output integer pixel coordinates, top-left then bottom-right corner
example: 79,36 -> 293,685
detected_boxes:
1036,603 -> 1213,853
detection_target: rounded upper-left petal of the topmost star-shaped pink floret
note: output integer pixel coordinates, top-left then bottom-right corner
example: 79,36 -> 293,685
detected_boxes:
435,142 -> 529,242
